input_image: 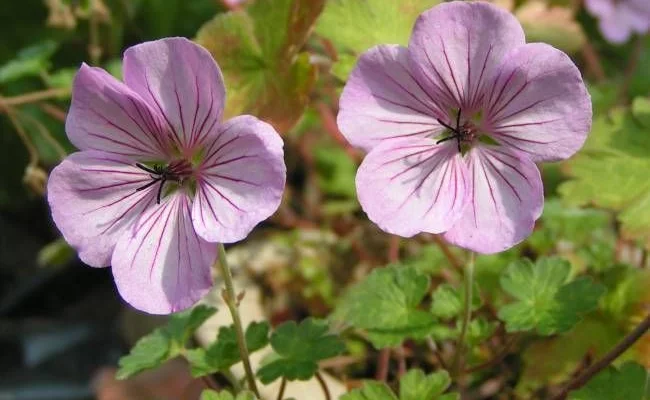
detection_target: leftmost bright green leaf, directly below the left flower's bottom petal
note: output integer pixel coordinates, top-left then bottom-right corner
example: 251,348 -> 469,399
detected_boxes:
116,305 -> 217,379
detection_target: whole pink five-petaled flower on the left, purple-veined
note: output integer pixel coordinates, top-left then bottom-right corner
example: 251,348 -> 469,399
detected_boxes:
48,38 -> 285,314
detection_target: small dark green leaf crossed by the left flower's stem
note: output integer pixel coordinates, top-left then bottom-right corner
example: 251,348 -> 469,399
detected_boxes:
185,321 -> 270,377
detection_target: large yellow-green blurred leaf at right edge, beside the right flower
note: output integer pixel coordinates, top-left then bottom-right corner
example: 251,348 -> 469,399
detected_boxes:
558,108 -> 650,248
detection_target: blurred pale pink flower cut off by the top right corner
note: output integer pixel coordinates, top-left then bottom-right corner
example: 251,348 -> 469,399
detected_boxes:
585,0 -> 650,44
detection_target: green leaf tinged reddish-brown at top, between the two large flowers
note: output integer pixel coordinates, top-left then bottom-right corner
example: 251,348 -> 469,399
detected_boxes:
196,0 -> 324,132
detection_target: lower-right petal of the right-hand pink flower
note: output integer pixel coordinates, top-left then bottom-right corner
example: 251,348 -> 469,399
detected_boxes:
444,146 -> 544,254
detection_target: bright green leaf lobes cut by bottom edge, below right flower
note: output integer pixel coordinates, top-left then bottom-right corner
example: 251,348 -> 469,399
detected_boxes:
341,369 -> 459,400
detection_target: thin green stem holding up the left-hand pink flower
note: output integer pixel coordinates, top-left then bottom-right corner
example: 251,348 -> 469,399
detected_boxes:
217,243 -> 260,398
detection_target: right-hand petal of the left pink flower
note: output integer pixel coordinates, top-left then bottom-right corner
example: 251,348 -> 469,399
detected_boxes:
192,115 -> 286,243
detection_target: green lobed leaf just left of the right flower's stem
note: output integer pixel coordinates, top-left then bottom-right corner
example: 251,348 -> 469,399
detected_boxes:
333,265 -> 436,348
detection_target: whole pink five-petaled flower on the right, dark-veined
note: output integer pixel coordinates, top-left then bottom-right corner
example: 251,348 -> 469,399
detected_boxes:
338,2 -> 591,253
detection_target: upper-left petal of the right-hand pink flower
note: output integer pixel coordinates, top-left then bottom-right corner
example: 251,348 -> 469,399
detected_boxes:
337,45 -> 446,151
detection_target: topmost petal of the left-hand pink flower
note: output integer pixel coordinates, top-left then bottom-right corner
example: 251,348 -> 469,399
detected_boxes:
123,38 -> 226,153
